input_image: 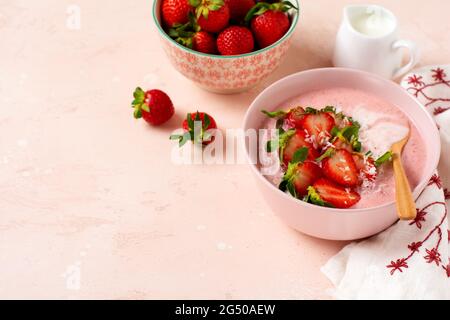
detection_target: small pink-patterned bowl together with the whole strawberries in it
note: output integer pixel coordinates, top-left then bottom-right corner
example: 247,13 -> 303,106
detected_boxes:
153,0 -> 299,93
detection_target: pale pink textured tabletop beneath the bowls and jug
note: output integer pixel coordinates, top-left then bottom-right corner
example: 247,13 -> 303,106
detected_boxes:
0,0 -> 450,299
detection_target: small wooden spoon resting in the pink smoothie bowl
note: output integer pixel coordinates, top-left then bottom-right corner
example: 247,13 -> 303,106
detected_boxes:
391,127 -> 417,220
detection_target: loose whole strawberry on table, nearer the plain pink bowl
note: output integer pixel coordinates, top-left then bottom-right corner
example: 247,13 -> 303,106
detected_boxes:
170,111 -> 217,147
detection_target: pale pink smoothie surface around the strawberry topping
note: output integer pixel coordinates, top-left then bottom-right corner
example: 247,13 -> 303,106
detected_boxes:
261,88 -> 426,209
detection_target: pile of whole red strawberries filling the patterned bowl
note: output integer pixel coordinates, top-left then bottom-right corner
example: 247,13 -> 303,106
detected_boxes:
161,0 -> 297,56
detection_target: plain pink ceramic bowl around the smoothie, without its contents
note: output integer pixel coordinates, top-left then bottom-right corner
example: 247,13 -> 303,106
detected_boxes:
244,68 -> 440,240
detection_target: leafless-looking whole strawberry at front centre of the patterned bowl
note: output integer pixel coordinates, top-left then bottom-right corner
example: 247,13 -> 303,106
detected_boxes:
217,26 -> 255,56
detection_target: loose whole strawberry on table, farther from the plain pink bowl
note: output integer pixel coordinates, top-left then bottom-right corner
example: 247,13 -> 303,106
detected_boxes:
132,88 -> 175,126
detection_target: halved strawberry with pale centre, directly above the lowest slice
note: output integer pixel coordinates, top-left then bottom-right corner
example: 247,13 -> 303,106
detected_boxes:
322,149 -> 359,187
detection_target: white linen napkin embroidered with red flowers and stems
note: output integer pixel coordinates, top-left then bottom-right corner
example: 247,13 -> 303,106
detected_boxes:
321,65 -> 450,299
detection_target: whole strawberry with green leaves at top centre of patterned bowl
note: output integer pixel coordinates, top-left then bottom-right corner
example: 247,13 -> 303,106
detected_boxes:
189,0 -> 230,33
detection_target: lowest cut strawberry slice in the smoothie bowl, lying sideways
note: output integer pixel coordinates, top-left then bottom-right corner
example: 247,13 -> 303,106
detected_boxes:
313,179 -> 361,209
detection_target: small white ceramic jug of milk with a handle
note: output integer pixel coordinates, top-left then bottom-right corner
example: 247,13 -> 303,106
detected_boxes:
334,5 -> 419,79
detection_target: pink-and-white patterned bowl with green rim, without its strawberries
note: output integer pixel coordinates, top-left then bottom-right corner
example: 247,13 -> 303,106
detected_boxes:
153,0 -> 299,94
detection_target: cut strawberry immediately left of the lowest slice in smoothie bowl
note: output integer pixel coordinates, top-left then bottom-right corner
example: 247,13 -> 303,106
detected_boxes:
285,161 -> 322,198
